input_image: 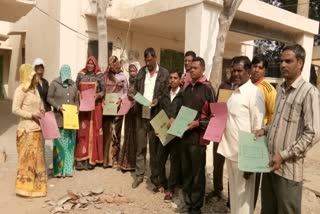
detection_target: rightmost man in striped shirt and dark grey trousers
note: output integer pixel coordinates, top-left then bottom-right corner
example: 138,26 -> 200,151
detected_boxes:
256,45 -> 320,214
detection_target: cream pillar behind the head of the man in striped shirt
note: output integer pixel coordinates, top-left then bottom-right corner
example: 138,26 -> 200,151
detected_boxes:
297,34 -> 314,81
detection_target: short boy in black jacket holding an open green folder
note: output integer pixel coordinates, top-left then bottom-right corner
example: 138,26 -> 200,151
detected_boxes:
159,71 -> 182,202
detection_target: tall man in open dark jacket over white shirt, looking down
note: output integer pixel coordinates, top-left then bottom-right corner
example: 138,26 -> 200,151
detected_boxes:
132,48 -> 169,188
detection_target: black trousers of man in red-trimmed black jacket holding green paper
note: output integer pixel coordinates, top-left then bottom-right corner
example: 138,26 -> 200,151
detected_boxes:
181,143 -> 206,213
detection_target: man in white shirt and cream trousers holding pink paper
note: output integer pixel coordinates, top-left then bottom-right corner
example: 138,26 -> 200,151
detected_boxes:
218,56 -> 265,214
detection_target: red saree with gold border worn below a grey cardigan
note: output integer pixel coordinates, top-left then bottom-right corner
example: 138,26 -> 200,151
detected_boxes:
75,83 -> 103,165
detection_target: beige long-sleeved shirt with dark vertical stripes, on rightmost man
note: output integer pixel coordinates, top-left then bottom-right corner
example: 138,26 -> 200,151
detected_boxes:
265,76 -> 320,182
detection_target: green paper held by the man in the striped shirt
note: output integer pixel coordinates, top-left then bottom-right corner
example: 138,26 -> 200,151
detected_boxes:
238,131 -> 270,172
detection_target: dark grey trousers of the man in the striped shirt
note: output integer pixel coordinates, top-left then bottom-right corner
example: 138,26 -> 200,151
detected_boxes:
261,173 -> 302,214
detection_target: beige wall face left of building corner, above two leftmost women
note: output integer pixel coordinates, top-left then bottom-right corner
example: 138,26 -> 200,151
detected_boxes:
21,0 -> 61,83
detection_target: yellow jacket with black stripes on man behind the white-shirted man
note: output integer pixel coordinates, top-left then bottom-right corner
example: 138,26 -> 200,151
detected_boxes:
255,79 -> 277,125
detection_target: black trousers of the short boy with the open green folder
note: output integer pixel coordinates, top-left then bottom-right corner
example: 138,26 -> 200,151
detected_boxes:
159,138 -> 181,192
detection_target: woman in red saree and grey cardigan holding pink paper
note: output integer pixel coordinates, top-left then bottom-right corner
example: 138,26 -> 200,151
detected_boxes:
75,56 -> 106,170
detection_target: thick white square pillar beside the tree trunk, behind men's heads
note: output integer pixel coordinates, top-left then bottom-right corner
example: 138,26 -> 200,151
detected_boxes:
184,3 -> 220,77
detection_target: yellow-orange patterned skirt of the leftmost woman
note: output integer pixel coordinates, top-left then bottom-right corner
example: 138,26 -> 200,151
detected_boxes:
16,130 -> 47,197
